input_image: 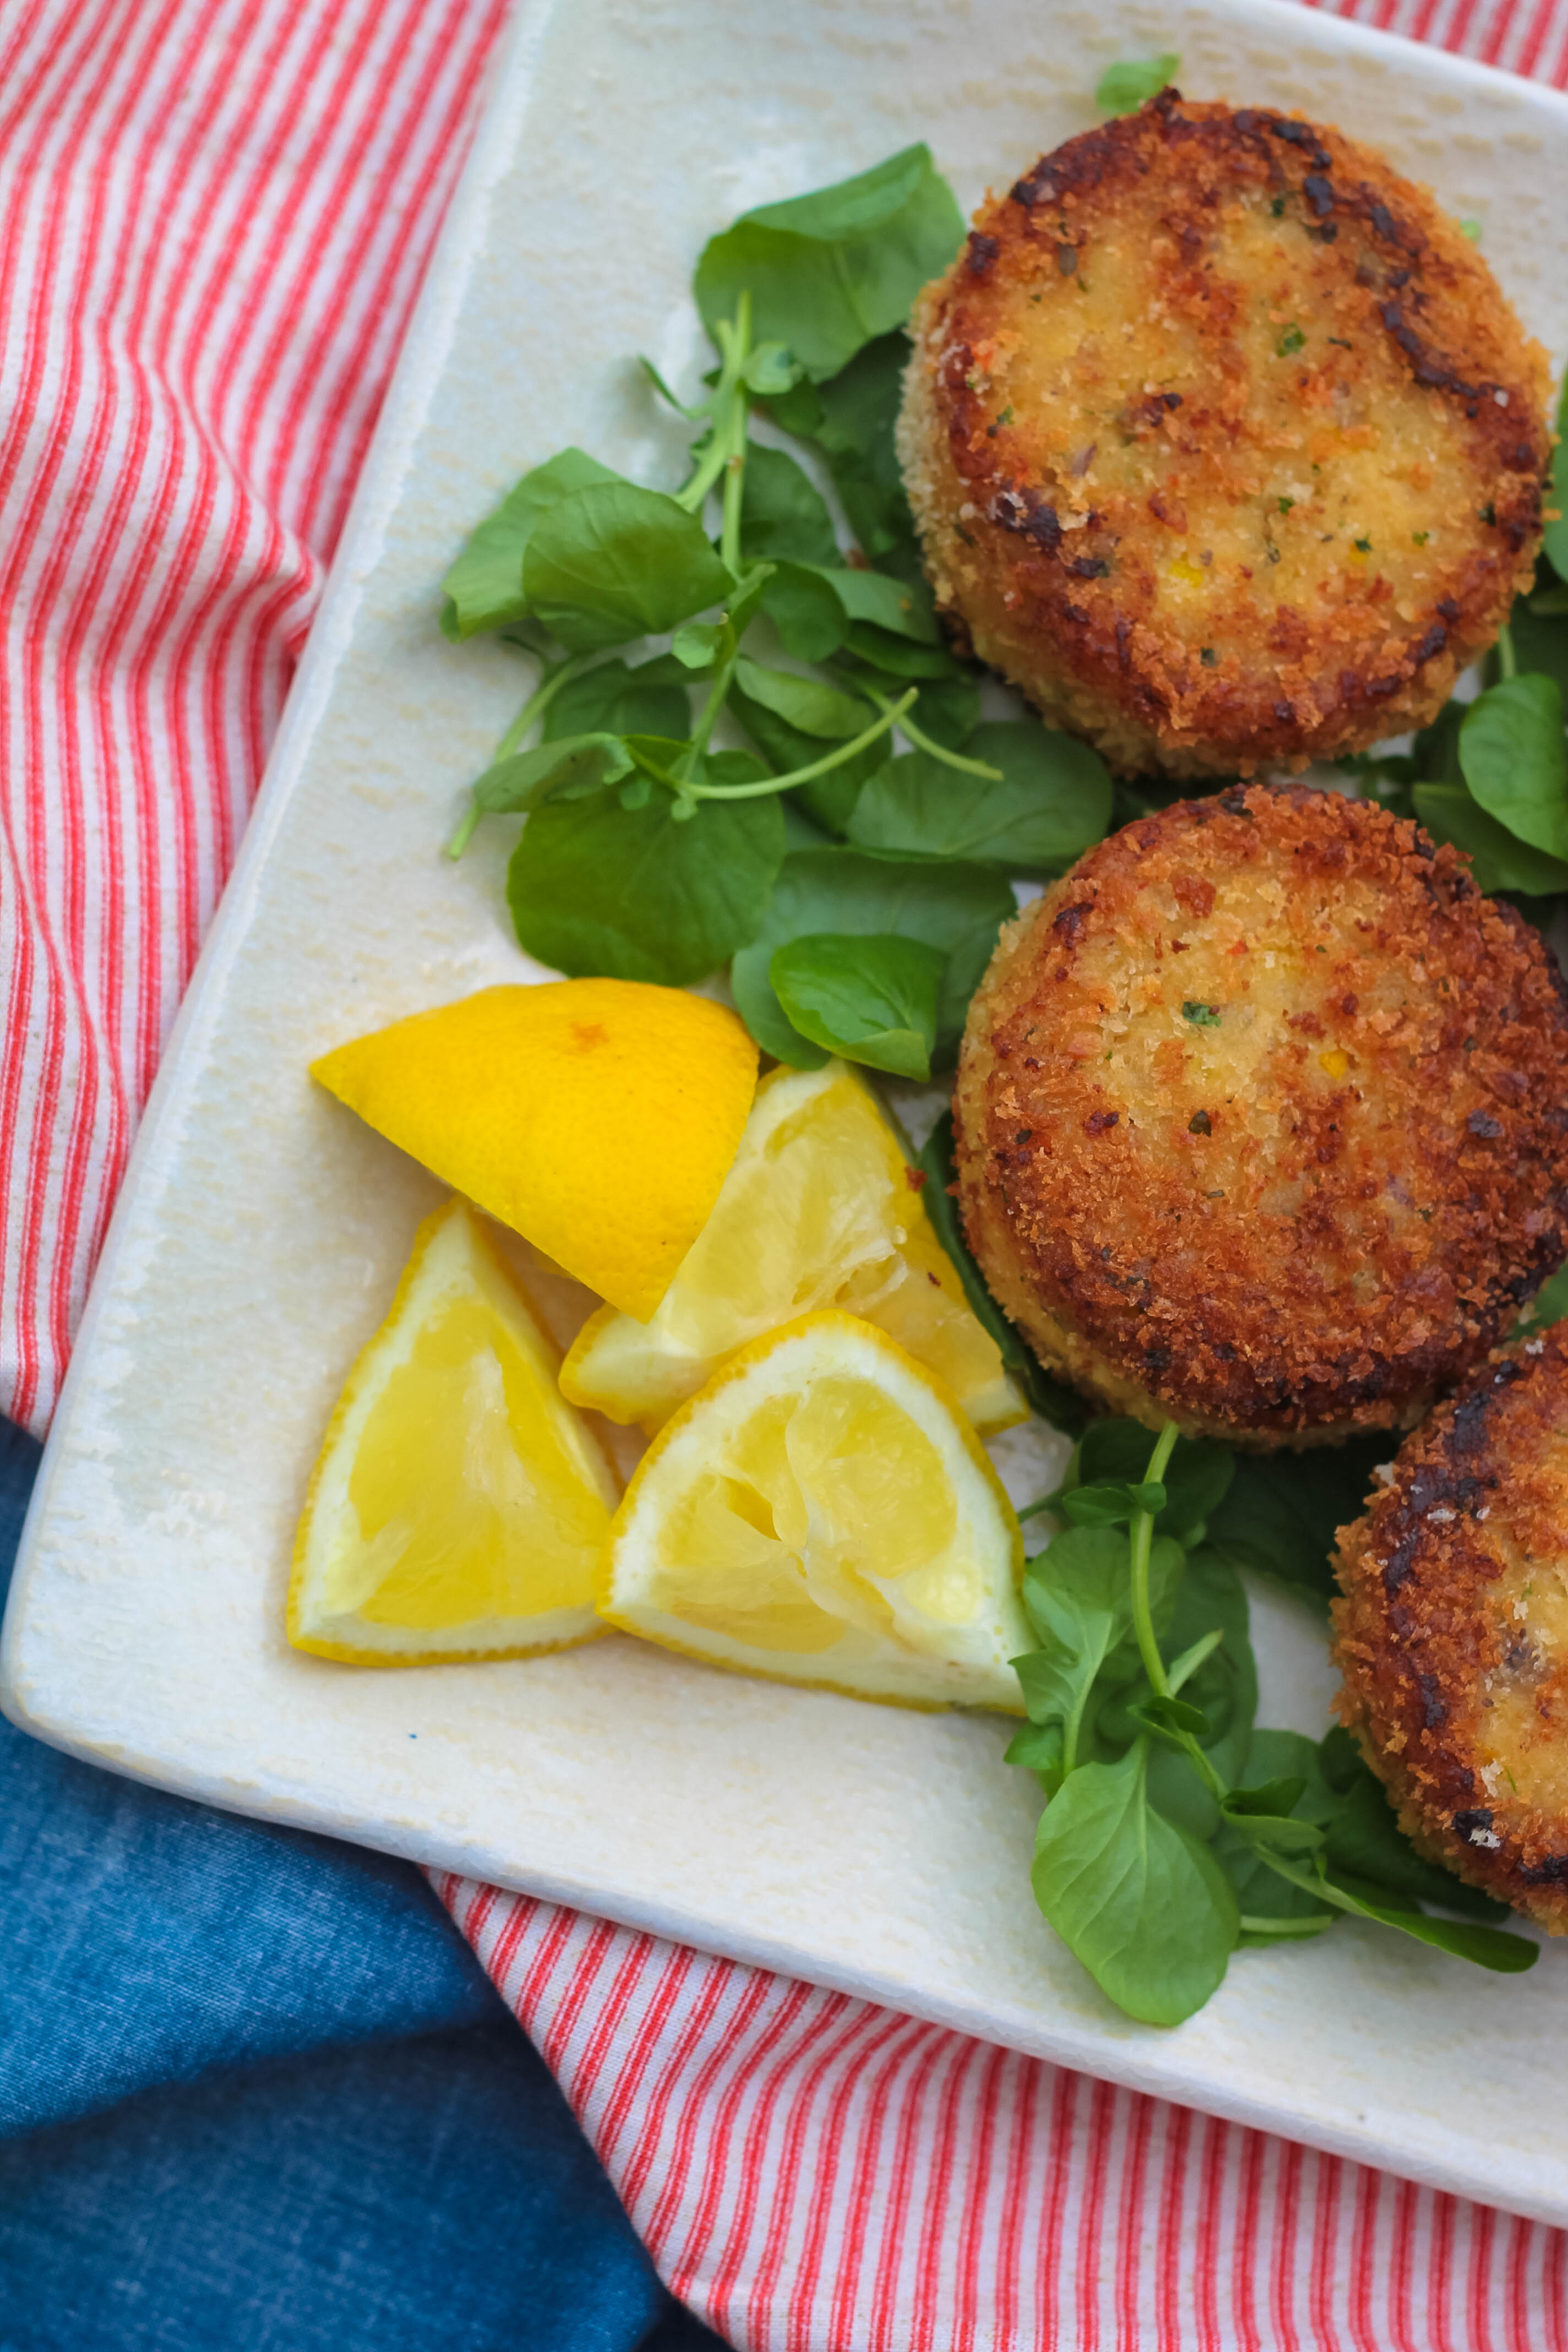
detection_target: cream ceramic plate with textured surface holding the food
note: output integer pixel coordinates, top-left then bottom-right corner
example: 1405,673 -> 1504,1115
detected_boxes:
5,0 -> 1568,2223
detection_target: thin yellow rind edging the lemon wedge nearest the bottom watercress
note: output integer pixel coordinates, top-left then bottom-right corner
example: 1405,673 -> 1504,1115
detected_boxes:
595,1308 -> 1035,1717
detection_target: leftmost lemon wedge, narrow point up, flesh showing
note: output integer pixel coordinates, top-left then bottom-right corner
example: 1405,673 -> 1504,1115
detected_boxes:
289,1200 -> 618,1665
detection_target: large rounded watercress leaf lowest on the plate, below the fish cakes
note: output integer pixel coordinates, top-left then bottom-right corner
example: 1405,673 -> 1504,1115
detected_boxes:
1030,1740 -> 1239,2025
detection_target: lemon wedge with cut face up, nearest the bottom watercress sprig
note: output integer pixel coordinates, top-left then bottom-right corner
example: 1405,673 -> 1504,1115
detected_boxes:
600,1310 -> 1035,1714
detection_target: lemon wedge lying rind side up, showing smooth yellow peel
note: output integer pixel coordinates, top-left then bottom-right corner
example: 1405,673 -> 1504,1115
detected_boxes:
311,981 -> 757,1315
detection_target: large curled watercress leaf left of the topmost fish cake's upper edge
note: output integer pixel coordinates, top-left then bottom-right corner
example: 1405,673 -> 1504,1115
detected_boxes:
694,146 -> 964,381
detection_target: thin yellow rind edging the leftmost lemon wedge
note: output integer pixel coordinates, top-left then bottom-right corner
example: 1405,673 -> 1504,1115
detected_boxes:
285,1197 -> 620,1668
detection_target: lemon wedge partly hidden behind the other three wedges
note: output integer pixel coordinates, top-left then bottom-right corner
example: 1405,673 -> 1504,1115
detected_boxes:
562,1061 -> 1027,1435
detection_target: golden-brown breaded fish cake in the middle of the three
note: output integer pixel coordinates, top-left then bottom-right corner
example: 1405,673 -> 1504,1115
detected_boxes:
955,783 -> 1568,1446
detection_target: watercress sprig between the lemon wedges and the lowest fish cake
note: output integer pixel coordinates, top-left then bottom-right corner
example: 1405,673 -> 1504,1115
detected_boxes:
1009,1423 -> 1535,2025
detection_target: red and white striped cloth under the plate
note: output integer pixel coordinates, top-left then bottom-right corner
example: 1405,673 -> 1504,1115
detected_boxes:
0,0 -> 1568,2352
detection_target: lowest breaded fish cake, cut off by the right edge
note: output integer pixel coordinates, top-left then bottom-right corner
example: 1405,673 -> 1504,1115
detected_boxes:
1333,1324 -> 1568,1936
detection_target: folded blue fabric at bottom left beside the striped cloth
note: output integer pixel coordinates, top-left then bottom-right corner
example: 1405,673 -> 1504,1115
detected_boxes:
0,1420 -> 717,2352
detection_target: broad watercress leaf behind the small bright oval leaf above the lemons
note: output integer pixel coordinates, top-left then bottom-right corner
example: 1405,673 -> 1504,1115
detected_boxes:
731,849 -> 1016,1070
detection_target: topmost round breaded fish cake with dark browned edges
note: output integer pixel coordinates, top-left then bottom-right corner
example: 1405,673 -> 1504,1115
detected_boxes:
898,89 -> 1551,776
